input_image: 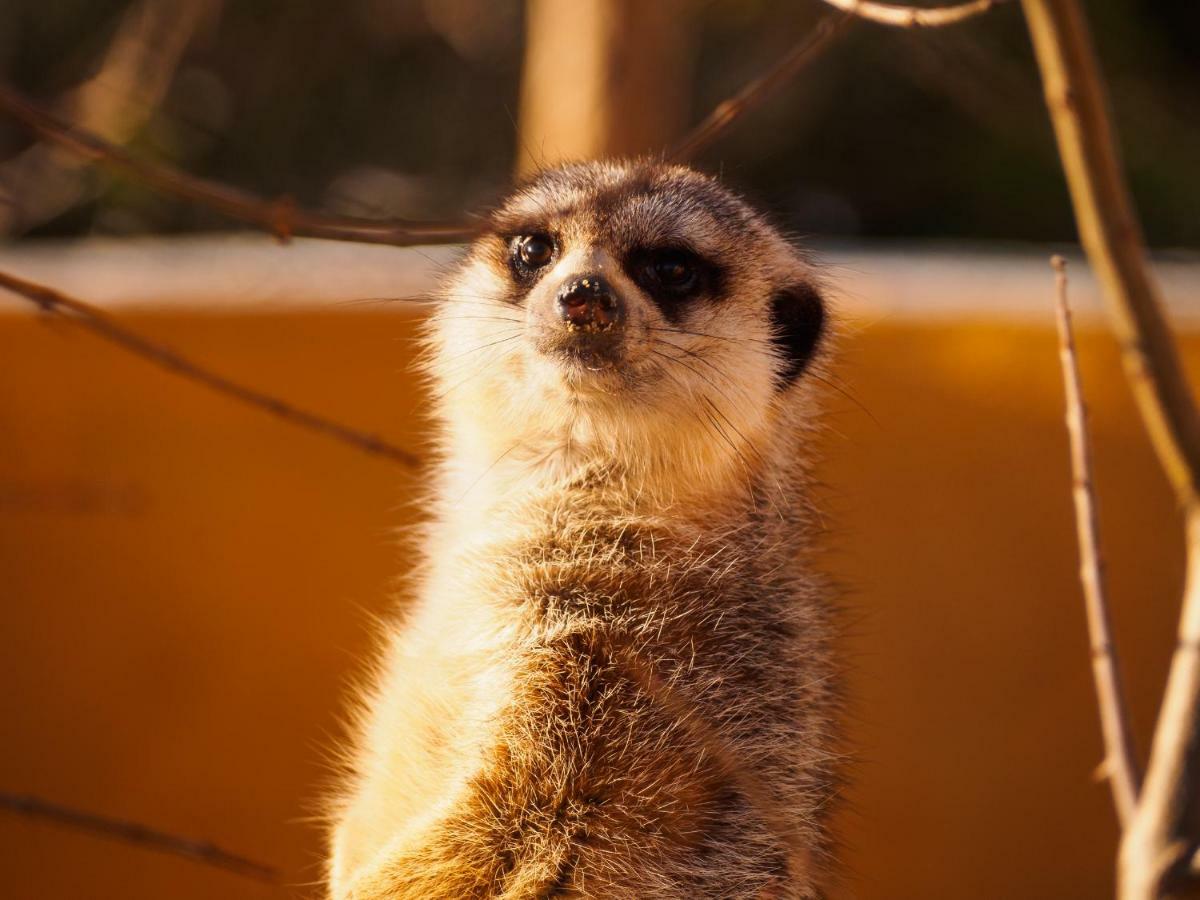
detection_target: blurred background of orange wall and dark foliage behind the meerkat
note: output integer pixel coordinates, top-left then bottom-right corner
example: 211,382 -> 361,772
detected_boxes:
0,0 -> 1200,900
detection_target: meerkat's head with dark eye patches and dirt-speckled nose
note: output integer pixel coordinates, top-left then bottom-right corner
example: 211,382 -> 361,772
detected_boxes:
430,161 -> 826,511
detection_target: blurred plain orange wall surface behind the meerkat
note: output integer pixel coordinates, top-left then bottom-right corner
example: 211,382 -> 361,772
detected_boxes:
0,313 -> 1185,900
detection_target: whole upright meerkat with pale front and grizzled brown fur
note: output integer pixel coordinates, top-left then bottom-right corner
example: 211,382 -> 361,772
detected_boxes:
329,162 -> 836,900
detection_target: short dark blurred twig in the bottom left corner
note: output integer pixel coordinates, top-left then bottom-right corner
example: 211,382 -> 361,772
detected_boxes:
0,792 -> 280,883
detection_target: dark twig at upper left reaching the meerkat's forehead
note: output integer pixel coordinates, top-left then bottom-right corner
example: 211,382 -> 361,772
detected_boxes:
0,84 -> 479,247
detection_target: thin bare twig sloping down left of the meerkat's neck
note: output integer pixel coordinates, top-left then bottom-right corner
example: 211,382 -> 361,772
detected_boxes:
0,271 -> 419,468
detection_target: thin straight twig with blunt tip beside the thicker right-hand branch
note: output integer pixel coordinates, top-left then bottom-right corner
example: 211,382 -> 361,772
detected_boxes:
1050,256 -> 1141,828
